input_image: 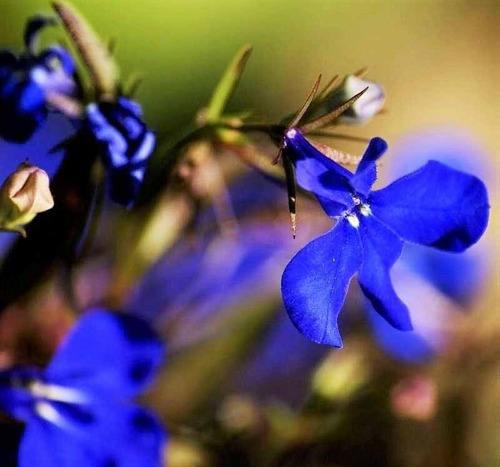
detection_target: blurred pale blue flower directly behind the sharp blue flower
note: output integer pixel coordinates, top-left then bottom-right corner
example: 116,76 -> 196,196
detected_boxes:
365,127 -> 491,363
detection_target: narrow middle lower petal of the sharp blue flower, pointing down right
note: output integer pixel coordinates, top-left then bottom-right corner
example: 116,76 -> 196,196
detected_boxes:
358,215 -> 412,331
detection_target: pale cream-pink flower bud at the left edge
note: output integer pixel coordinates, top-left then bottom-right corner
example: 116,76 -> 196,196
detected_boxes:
0,162 -> 54,236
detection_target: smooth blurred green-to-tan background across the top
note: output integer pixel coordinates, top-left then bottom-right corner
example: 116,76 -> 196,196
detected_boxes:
0,0 -> 500,153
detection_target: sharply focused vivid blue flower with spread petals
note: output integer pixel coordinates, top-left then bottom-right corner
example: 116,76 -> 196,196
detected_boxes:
282,128 -> 489,347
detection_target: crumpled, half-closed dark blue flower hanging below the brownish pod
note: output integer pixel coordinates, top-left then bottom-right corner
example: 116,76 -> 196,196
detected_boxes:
87,97 -> 155,206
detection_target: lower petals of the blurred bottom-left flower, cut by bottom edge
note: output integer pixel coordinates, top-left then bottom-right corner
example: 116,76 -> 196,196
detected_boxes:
19,405 -> 166,467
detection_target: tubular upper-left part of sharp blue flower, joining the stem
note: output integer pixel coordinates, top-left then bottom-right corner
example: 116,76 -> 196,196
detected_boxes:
285,129 -> 354,216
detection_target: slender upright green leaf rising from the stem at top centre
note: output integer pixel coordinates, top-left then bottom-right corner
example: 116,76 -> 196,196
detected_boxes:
205,45 -> 252,123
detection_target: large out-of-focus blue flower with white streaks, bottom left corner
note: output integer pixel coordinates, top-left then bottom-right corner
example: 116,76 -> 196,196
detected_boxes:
0,310 -> 165,467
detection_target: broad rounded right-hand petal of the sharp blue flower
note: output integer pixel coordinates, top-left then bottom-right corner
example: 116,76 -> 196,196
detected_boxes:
370,161 -> 489,251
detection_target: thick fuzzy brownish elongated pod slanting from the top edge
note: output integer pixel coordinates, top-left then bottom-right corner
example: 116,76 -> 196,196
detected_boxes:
52,0 -> 118,100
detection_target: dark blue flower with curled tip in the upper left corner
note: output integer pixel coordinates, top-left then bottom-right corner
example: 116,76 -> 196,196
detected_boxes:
0,16 -> 76,143
